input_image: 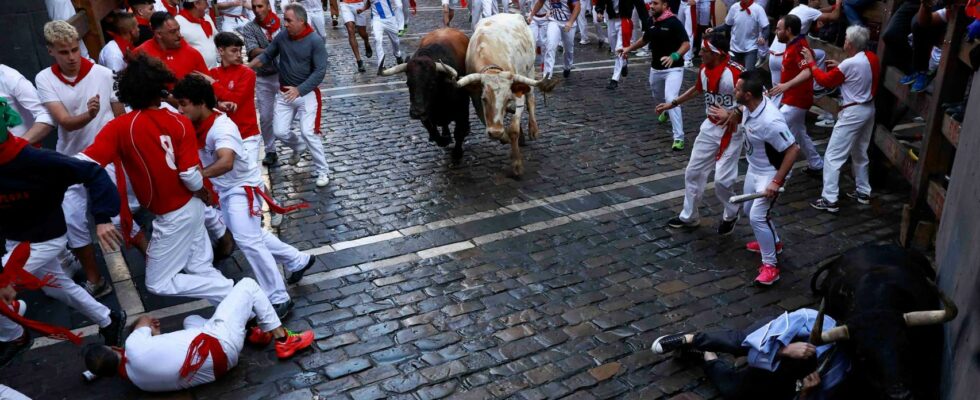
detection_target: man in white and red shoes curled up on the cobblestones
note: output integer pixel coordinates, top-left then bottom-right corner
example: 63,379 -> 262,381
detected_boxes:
84,278 -> 313,392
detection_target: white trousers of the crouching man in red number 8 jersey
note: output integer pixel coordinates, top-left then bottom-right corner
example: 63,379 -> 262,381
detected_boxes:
146,197 -> 232,304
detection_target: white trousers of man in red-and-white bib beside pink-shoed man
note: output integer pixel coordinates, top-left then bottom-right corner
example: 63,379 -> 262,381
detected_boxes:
680,120 -> 743,222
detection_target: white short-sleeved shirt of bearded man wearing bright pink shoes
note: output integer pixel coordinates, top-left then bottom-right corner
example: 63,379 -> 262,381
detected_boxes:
742,97 -> 796,174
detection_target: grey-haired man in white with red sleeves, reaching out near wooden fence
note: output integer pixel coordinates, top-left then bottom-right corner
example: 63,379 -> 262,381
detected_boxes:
803,25 -> 881,213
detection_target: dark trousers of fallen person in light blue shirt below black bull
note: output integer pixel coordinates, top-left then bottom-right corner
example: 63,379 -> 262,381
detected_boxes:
694,323 -> 817,400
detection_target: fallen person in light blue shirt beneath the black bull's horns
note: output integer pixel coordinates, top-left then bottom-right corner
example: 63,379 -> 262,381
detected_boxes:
651,308 -> 850,400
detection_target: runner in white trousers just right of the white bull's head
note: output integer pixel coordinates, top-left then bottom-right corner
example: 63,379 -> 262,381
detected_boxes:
527,0 -> 582,79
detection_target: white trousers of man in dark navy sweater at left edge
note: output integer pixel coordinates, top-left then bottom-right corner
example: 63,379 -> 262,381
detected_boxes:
0,235 -> 111,341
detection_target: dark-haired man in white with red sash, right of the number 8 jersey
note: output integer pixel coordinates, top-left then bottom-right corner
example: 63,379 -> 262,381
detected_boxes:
173,75 -> 316,319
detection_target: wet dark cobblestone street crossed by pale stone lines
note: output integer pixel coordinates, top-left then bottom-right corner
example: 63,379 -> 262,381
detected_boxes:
0,0 -> 907,400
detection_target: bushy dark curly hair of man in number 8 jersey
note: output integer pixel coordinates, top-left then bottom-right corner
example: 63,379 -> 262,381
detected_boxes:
116,53 -> 177,110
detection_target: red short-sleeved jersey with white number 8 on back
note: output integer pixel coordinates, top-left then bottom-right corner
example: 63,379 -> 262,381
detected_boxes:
82,109 -> 201,215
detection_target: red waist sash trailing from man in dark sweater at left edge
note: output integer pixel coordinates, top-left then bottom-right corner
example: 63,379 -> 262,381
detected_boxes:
0,242 -> 82,345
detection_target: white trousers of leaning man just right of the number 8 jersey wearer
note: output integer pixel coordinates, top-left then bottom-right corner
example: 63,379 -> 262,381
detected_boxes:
220,187 -> 311,304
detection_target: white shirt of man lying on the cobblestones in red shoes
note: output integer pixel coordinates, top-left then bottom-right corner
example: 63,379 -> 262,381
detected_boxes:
126,326 -> 238,392
